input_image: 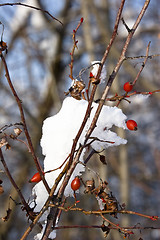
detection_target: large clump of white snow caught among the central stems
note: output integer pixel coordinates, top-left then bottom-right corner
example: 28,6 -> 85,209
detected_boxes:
32,97 -> 127,239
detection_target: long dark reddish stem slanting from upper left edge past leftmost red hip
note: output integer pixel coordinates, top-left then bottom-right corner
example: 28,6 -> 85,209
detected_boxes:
0,53 -> 50,193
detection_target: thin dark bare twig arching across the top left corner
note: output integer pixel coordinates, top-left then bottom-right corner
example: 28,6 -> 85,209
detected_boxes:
0,2 -> 63,25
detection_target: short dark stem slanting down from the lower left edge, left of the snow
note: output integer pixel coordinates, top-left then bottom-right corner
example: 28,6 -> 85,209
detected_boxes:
0,148 -> 33,219
